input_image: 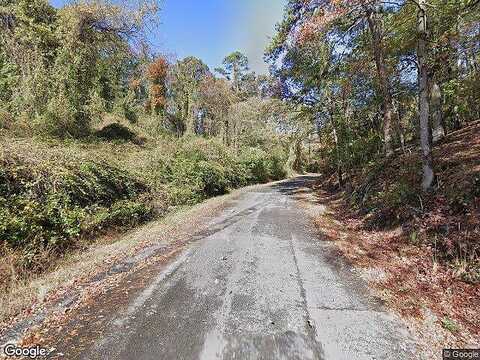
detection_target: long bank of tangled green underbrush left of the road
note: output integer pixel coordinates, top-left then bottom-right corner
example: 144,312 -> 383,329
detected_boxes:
0,131 -> 286,287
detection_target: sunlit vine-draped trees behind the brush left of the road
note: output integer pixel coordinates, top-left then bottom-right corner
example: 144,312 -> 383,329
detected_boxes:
0,0 -> 300,159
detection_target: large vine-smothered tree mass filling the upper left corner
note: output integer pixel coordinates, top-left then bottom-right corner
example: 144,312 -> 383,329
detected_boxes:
0,0 -> 158,136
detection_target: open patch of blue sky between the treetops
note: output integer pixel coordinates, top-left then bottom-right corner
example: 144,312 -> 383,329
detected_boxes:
50,0 -> 286,73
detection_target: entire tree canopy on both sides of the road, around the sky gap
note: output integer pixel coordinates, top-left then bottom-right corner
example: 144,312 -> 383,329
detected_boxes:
0,0 -> 480,190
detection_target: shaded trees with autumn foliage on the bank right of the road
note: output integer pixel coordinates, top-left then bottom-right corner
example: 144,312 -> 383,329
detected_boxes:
266,0 -> 480,190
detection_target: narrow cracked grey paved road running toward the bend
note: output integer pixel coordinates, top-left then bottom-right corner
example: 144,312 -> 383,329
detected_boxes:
54,176 -> 415,360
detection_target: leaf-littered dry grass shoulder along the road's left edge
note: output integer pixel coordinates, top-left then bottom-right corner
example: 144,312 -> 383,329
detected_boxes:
0,184 -> 278,346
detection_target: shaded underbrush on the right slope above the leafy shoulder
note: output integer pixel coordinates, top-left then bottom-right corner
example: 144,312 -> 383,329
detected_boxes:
322,122 -> 480,283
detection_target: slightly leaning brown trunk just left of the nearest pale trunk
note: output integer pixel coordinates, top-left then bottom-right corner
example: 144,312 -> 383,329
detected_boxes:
367,5 -> 393,157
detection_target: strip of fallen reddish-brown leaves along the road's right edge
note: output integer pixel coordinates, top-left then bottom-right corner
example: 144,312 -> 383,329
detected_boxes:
297,185 -> 480,359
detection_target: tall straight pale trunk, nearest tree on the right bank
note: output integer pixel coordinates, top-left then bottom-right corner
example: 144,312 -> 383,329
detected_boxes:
417,0 -> 435,191
